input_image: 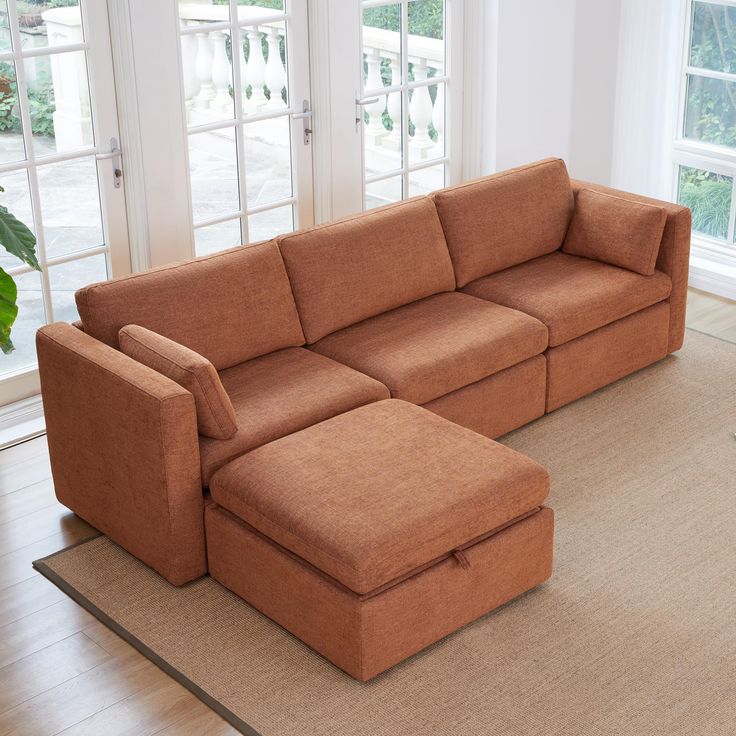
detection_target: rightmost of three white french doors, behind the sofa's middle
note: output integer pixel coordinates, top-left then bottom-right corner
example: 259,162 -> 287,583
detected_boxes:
356,0 -> 462,209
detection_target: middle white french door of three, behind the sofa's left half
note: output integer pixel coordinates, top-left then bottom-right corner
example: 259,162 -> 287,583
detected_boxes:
178,0 -> 314,255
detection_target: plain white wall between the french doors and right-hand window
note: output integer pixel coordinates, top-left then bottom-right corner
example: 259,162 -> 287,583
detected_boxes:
495,0 -> 621,184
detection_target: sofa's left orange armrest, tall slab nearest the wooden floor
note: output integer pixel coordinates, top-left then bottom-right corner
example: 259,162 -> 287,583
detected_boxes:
36,323 -> 206,585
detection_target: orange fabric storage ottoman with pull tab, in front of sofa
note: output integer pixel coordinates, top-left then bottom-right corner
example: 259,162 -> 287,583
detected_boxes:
205,399 -> 553,680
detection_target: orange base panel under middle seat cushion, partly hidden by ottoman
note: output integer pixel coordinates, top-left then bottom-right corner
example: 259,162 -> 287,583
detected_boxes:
423,355 -> 547,439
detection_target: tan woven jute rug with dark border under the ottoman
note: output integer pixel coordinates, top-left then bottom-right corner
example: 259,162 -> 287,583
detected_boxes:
36,332 -> 736,736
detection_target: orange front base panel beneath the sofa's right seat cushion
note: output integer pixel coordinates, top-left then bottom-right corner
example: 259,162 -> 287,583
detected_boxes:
547,302 -> 670,411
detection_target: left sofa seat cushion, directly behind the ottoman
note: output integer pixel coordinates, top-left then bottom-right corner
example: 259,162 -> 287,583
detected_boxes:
199,348 -> 389,486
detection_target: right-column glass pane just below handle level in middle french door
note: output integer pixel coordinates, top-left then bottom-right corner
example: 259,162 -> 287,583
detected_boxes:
245,116 -> 293,208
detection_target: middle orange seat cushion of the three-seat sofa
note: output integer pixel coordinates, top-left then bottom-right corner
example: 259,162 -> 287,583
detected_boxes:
312,292 -> 547,404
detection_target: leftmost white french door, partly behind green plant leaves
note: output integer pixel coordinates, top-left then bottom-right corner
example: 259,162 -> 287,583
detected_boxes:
0,0 -> 130,405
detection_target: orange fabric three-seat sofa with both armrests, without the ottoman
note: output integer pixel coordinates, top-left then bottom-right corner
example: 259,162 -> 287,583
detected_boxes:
37,159 -> 690,677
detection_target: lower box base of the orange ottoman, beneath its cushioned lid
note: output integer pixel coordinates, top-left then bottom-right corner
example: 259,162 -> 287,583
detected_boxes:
205,504 -> 554,681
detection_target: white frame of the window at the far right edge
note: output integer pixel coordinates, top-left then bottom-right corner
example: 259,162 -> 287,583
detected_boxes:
672,0 -> 736,299
